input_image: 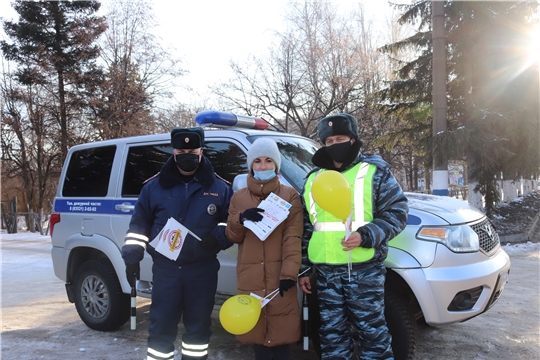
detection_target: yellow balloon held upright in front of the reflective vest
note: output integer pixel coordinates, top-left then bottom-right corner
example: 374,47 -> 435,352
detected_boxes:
311,170 -> 352,222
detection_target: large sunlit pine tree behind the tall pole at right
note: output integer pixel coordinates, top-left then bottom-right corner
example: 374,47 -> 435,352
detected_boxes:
381,1 -> 540,214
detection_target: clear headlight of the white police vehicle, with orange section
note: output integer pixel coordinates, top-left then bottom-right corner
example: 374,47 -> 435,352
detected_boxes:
416,225 -> 480,252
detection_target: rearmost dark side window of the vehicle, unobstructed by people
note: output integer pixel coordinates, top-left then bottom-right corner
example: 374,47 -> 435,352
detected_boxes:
62,145 -> 116,197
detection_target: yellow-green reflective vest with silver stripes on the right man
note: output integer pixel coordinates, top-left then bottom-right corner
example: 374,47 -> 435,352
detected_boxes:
304,162 -> 377,265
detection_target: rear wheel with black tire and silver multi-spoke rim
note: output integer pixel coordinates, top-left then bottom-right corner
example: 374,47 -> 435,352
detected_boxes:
73,260 -> 130,331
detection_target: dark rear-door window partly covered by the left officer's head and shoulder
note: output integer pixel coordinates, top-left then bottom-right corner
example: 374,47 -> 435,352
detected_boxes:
122,143 -> 173,197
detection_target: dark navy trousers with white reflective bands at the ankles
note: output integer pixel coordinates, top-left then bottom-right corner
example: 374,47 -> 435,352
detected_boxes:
148,259 -> 219,360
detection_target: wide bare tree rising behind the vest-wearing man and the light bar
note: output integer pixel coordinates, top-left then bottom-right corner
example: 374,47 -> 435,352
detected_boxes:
213,1 -> 392,141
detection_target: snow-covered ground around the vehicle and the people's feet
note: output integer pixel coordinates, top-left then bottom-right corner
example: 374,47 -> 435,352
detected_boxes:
0,231 -> 540,360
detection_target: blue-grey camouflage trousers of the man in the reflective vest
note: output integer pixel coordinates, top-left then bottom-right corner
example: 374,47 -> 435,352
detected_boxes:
317,263 -> 393,360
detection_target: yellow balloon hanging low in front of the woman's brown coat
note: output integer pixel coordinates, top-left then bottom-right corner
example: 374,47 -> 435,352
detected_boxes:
219,295 -> 261,335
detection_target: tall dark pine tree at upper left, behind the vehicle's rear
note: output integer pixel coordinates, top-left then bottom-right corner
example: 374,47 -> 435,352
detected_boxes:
1,0 -> 106,159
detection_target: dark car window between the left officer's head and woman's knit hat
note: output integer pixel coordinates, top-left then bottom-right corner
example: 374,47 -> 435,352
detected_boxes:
203,141 -> 247,183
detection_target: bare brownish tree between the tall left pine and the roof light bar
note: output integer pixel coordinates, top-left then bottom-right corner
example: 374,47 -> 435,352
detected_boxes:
93,0 -> 184,139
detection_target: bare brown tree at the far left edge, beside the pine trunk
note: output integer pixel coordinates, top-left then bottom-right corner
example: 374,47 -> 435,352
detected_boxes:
0,62 -> 61,215
